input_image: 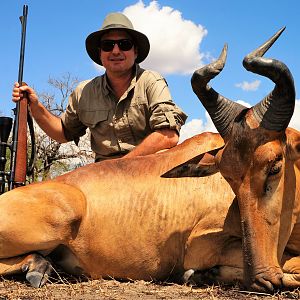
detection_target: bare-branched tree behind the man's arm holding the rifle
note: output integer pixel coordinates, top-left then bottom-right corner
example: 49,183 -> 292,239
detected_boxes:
32,73 -> 93,181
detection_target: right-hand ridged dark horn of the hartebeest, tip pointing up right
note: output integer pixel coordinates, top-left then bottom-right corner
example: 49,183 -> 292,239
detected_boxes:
243,27 -> 296,131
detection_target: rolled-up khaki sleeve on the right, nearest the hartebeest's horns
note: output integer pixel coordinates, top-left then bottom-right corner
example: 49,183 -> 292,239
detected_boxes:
147,72 -> 187,134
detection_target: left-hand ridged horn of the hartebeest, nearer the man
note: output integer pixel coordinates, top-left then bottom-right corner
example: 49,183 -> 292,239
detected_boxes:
191,44 -> 246,138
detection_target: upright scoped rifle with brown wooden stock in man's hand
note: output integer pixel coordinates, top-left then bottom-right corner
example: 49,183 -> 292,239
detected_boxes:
0,5 -> 35,194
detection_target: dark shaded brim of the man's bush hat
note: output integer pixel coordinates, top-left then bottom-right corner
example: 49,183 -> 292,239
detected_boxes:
85,27 -> 150,66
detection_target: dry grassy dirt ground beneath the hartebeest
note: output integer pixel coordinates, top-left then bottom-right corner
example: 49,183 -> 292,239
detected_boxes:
0,277 -> 300,300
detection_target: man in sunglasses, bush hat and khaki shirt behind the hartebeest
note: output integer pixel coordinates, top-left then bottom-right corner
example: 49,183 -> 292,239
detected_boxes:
13,13 -> 187,161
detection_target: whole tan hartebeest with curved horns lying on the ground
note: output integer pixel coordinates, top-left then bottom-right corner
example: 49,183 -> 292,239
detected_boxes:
0,31 -> 300,291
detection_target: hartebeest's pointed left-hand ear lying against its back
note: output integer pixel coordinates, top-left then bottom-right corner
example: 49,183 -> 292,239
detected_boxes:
161,147 -> 223,178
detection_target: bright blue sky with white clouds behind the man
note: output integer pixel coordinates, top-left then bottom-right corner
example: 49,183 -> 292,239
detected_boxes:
0,0 -> 300,140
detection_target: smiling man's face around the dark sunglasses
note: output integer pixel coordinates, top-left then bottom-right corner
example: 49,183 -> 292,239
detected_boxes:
100,30 -> 137,75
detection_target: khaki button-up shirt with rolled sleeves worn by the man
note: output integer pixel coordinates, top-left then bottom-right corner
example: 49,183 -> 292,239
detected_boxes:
62,65 -> 187,161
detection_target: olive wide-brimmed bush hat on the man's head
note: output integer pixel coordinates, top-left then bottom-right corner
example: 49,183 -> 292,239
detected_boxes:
85,13 -> 150,65
